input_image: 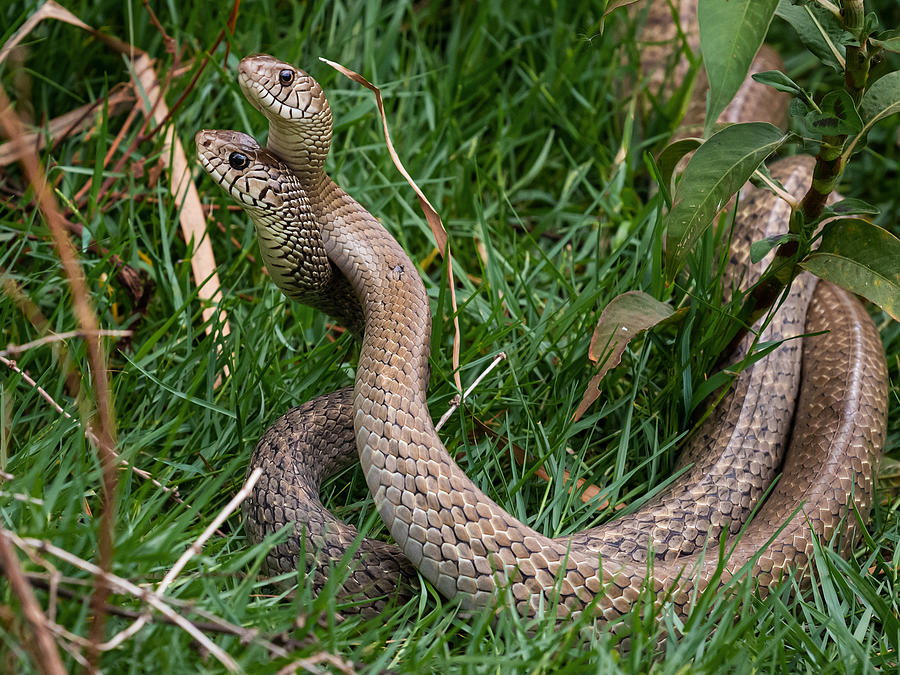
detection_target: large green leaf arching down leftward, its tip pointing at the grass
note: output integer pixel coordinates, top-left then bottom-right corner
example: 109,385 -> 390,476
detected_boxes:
665,122 -> 786,283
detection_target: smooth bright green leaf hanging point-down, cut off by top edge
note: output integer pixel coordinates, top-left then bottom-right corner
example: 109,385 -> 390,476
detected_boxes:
697,0 -> 778,132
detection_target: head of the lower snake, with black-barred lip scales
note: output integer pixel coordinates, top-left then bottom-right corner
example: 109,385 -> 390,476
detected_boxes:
194,129 -> 296,213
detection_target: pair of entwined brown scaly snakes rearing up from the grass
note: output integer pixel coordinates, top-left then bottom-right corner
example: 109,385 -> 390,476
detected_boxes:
197,9 -> 887,619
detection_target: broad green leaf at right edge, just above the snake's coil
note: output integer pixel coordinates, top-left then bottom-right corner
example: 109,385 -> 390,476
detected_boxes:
800,218 -> 900,320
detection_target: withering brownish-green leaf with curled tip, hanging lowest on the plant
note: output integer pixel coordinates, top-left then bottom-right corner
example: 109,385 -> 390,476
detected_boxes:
574,291 -> 675,420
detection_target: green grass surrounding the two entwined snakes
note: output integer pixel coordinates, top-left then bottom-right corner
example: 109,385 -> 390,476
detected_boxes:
0,0 -> 900,673
